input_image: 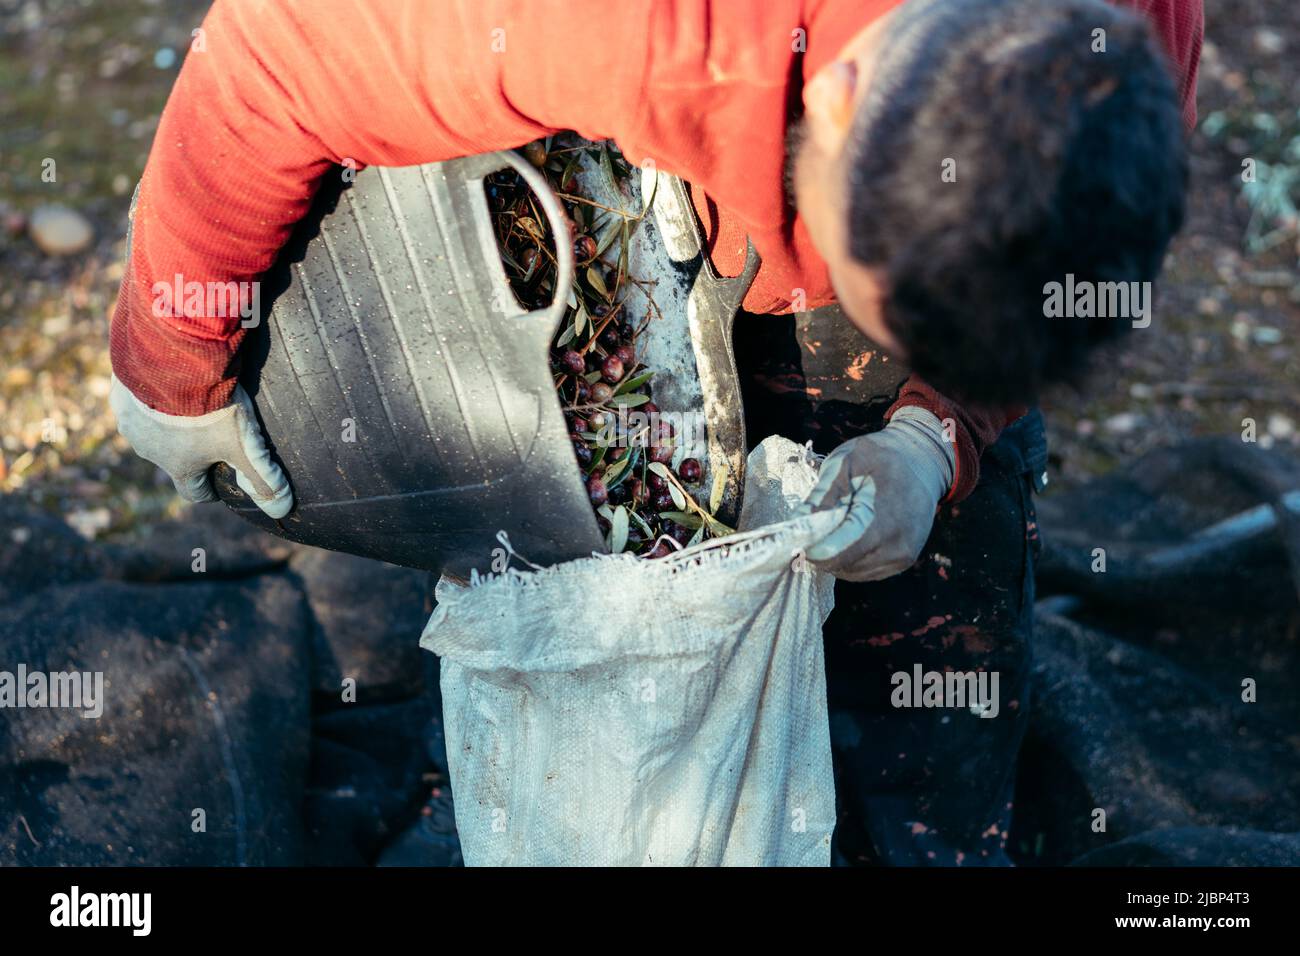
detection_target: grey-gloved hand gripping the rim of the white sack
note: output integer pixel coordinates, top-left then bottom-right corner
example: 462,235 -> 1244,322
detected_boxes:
802,407 -> 956,581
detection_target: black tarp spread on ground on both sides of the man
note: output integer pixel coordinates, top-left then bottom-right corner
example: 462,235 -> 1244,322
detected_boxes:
0,440 -> 1300,865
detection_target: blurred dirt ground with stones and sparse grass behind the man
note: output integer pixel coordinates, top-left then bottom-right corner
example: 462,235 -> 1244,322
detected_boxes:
0,0 -> 1300,537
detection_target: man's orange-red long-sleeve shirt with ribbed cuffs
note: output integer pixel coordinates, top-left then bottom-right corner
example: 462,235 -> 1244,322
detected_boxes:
111,0 -> 1203,498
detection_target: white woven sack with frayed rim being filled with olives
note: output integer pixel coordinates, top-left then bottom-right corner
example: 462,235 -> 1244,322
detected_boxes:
420,438 -> 840,865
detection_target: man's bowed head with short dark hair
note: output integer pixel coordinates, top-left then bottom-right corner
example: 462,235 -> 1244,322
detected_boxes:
793,0 -> 1187,402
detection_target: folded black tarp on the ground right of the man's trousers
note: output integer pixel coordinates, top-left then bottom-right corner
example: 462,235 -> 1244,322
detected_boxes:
1013,438 -> 1300,865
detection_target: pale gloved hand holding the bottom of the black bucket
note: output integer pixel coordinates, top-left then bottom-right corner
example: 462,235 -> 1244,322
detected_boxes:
108,376 -> 294,520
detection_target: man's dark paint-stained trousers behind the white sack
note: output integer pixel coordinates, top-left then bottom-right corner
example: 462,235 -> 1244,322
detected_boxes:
735,310 -> 1047,866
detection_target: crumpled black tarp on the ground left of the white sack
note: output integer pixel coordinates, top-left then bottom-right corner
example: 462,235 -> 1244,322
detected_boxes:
0,501 -> 454,865
